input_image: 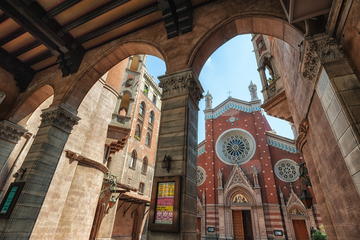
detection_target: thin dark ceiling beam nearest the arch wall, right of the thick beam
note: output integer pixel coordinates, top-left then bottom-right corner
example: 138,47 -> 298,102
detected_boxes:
77,3 -> 158,43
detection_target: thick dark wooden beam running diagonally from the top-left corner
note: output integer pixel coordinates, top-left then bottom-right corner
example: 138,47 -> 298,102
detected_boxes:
0,0 -> 85,76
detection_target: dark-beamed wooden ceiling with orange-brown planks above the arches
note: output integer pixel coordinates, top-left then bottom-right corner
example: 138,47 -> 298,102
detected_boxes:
0,0 -> 332,90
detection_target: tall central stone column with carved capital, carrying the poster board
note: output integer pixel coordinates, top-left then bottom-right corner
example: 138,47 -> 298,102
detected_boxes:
148,69 -> 203,240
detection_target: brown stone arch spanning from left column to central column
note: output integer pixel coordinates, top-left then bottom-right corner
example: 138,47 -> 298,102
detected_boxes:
59,41 -> 166,109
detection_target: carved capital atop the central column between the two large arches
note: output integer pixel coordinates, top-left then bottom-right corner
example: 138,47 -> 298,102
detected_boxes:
159,69 -> 204,104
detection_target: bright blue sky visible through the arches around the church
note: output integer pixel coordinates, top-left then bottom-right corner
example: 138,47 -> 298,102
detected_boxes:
146,34 -> 294,143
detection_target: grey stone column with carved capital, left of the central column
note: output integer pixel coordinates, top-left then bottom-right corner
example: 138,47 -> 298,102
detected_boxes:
0,105 -> 79,239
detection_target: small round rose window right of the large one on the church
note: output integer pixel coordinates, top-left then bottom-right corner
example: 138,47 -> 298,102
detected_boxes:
274,159 -> 300,182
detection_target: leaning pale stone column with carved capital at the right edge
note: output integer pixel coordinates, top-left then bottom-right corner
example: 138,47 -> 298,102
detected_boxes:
301,33 -> 360,196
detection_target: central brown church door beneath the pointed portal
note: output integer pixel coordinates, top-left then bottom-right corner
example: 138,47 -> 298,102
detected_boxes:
232,210 -> 253,240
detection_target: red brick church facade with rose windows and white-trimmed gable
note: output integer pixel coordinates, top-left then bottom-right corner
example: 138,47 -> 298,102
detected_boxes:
197,87 -> 321,240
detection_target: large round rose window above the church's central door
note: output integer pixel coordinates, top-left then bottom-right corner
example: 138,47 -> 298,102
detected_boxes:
216,129 -> 255,165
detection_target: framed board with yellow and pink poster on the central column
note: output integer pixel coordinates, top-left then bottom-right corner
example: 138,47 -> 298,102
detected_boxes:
150,176 -> 181,232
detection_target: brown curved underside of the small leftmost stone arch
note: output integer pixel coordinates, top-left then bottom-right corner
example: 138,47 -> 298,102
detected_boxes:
9,84 -> 54,123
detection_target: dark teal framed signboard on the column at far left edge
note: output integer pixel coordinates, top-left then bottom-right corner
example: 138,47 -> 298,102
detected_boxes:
0,182 -> 25,218
